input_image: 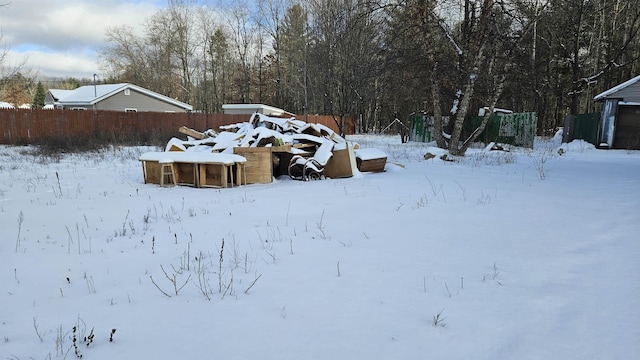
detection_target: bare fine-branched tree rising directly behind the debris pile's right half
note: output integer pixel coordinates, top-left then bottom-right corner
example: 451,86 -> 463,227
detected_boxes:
309,0 -> 383,132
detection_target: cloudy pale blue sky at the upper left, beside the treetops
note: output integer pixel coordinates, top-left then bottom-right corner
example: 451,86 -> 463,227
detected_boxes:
0,0 -> 166,78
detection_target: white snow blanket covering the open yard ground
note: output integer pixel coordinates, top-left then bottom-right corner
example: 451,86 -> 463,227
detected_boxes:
0,136 -> 640,359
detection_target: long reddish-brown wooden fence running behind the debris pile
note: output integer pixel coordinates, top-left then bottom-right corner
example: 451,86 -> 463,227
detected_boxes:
0,109 -> 354,145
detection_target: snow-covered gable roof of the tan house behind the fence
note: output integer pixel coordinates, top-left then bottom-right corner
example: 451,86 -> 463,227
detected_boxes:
49,83 -> 193,111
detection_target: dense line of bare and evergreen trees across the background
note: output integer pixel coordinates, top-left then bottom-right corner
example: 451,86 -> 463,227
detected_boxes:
2,0 -> 640,155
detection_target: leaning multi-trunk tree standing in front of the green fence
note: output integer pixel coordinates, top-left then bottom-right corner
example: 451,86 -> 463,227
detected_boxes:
422,0 -> 531,156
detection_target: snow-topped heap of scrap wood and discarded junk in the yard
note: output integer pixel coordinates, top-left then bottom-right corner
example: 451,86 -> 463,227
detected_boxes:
145,113 -> 386,187
